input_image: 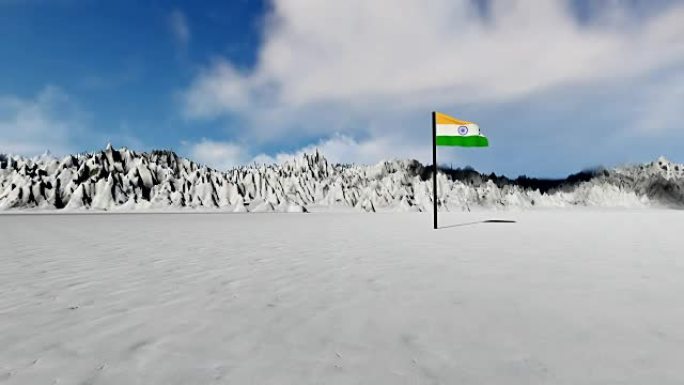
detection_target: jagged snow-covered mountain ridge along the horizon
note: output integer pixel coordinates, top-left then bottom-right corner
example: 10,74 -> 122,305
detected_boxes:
0,146 -> 684,212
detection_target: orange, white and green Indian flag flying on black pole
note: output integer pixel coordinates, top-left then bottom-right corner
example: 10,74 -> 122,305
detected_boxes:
435,112 -> 489,147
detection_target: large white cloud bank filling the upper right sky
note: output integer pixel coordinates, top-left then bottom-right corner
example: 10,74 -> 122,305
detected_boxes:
186,0 -> 684,117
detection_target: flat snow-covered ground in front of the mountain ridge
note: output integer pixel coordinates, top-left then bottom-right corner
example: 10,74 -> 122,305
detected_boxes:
0,210 -> 684,385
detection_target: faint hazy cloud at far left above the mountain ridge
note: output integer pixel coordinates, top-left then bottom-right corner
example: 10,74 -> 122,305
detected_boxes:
0,86 -> 82,155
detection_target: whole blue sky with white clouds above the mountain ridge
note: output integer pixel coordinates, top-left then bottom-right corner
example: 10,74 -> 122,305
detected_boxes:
0,0 -> 684,176
